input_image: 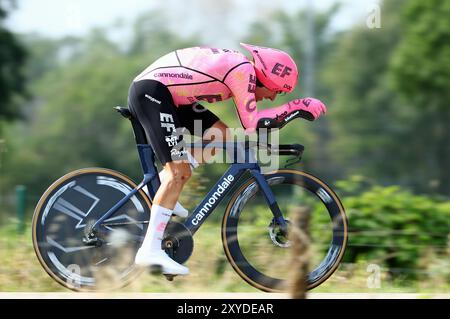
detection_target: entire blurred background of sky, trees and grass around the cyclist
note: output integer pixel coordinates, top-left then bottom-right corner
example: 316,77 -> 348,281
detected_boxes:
0,0 -> 450,293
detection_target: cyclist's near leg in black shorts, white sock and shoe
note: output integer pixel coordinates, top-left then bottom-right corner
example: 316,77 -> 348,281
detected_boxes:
129,80 -> 191,275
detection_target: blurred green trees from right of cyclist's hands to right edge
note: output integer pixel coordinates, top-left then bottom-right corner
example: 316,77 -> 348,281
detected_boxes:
323,0 -> 450,195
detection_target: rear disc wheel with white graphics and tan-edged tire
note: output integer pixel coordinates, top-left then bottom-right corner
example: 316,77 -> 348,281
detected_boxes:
32,168 -> 151,291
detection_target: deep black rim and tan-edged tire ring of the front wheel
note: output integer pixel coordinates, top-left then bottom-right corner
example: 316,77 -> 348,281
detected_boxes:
222,170 -> 348,292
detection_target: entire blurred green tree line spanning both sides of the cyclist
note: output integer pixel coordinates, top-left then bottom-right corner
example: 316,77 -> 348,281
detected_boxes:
0,0 -> 450,196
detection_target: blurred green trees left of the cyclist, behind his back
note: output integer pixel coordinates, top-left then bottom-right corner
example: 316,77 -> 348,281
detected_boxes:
0,13 -> 200,204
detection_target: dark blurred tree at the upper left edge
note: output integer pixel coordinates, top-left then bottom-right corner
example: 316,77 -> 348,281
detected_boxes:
0,0 -> 26,124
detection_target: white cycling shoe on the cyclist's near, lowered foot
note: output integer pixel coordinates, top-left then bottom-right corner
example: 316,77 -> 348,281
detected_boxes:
134,248 -> 189,276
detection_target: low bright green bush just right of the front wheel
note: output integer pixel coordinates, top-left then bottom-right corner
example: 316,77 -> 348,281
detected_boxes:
337,176 -> 450,278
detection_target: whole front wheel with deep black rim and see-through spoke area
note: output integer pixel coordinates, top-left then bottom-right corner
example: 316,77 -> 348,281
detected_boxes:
222,170 -> 348,292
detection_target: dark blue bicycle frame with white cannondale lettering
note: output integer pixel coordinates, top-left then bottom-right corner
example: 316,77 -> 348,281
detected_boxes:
88,107 -> 304,238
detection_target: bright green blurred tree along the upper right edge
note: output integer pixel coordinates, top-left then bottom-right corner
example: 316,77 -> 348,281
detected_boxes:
391,0 -> 450,194
